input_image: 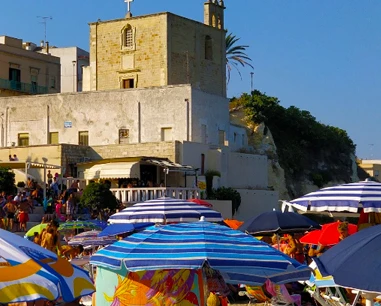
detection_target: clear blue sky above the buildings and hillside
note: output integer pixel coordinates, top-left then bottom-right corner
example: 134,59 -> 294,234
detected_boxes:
0,0 -> 381,159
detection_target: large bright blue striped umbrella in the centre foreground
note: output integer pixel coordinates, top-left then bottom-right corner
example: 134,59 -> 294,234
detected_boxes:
90,221 -> 311,285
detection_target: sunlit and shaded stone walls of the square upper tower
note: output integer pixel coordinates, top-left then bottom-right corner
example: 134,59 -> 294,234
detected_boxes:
84,13 -> 226,96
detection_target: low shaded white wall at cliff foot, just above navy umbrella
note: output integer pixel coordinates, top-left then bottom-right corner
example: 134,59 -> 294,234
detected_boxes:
234,189 -> 280,221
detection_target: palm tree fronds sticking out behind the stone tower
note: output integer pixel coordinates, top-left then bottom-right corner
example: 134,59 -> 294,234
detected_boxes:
225,33 -> 254,83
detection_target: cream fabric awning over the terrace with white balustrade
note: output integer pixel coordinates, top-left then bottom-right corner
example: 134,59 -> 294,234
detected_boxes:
84,162 -> 140,180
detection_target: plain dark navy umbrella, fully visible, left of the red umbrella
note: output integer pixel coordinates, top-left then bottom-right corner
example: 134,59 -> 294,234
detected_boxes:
239,211 -> 321,235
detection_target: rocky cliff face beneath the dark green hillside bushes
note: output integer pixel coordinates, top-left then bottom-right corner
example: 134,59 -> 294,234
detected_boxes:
230,105 -> 359,200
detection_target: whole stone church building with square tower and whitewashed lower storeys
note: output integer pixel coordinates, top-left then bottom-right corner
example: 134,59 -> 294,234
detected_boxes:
0,0 -> 278,220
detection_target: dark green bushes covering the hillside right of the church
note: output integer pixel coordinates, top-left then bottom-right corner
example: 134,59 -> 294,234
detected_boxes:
230,90 -> 355,197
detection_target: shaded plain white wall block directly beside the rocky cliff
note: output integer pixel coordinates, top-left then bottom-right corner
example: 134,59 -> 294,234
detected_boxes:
228,152 -> 268,189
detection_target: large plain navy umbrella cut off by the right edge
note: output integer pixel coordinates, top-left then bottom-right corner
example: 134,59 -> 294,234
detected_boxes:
314,225 -> 381,293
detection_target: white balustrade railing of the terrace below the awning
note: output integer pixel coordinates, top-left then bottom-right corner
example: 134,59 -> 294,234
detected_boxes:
110,187 -> 200,204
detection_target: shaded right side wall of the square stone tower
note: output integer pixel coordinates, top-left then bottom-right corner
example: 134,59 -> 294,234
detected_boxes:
168,14 -> 226,97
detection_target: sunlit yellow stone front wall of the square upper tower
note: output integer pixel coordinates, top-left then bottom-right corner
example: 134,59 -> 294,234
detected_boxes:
90,13 -> 167,90
